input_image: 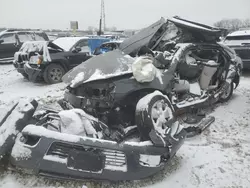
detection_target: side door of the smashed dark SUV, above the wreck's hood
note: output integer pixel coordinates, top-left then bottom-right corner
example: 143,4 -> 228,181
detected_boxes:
67,39 -> 91,67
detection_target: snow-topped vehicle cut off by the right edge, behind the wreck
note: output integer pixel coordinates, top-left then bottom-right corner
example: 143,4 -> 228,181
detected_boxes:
223,30 -> 250,69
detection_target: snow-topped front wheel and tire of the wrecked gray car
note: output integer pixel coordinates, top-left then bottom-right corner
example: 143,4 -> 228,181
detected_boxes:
135,94 -> 175,140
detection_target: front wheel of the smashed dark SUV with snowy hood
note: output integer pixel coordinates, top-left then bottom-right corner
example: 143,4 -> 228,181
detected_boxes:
43,64 -> 65,84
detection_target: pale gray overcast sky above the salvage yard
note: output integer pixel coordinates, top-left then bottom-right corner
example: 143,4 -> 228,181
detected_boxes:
0,0 -> 250,29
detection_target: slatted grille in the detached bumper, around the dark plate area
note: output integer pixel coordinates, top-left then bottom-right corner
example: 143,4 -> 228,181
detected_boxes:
47,142 -> 127,171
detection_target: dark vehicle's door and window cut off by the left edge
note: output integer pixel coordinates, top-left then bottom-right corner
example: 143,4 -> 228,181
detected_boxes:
0,33 -> 19,61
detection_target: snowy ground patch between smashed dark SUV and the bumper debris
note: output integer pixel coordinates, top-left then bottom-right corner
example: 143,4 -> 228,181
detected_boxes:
0,65 -> 66,106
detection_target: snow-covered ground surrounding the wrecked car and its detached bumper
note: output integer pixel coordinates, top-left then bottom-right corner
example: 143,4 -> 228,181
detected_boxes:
0,65 -> 250,188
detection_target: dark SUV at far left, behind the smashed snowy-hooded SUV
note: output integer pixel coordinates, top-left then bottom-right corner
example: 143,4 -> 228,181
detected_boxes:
0,29 -> 49,63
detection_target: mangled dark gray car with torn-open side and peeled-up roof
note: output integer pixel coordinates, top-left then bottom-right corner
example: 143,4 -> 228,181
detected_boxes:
60,17 -> 242,139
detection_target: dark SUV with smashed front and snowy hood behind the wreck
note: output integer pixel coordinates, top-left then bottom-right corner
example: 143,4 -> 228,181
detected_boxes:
14,37 -> 108,84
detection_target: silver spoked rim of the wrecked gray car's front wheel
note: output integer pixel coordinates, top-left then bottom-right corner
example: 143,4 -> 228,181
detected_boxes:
151,100 -> 173,134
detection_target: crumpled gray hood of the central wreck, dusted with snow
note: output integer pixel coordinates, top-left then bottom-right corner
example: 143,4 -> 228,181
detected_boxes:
62,50 -> 134,88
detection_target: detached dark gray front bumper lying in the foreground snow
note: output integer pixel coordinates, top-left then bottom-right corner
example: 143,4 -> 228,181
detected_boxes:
11,125 -> 186,181
